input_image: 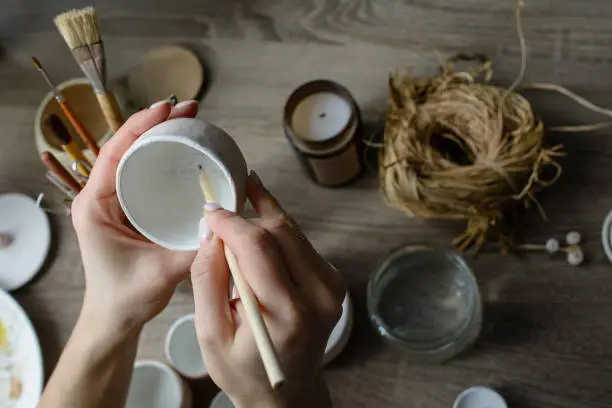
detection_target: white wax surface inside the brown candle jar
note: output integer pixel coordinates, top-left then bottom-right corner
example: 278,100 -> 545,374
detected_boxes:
291,92 -> 351,142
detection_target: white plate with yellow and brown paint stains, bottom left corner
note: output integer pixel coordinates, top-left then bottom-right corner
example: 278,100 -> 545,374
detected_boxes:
0,290 -> 43,408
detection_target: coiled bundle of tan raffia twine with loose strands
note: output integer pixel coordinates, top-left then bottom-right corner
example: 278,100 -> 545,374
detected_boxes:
378,2 -> 611,252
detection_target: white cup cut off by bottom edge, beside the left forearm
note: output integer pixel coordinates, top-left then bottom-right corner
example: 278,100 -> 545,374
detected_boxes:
125,360 -> 193,408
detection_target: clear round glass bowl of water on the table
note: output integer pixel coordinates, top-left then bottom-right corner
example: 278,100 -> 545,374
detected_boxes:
367,246 -> 482,362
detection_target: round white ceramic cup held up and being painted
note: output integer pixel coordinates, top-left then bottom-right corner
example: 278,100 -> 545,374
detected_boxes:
117,118 -> 247,251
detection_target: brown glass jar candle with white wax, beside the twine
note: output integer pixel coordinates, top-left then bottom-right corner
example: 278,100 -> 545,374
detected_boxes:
283,80 -> 364,187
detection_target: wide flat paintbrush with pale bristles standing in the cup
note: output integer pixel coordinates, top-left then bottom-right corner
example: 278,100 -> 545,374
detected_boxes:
54,7 -> 123,132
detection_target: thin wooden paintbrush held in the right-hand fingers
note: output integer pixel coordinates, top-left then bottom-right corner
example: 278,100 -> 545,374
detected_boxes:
198,166 -> 286,389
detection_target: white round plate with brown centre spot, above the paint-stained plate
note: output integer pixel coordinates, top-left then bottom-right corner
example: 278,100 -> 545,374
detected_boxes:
0,194 -> 51,291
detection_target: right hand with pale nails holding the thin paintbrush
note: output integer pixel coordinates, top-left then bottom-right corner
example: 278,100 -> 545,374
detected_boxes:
191,172 -> 346,408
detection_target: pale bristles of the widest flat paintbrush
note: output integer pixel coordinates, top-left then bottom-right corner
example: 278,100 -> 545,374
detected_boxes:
54,7 -> 101,49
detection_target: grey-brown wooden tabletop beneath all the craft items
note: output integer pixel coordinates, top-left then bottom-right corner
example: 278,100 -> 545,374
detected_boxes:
0,0 -> 612,408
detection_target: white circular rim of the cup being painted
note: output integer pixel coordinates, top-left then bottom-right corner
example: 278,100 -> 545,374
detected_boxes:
115,133 -> 238,251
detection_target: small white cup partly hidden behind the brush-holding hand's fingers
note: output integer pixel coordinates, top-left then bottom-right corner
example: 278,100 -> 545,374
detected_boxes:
165,313 -> 208,379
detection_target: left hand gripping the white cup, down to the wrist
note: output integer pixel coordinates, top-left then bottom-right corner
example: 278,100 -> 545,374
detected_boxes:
72,101 -> 198,340
